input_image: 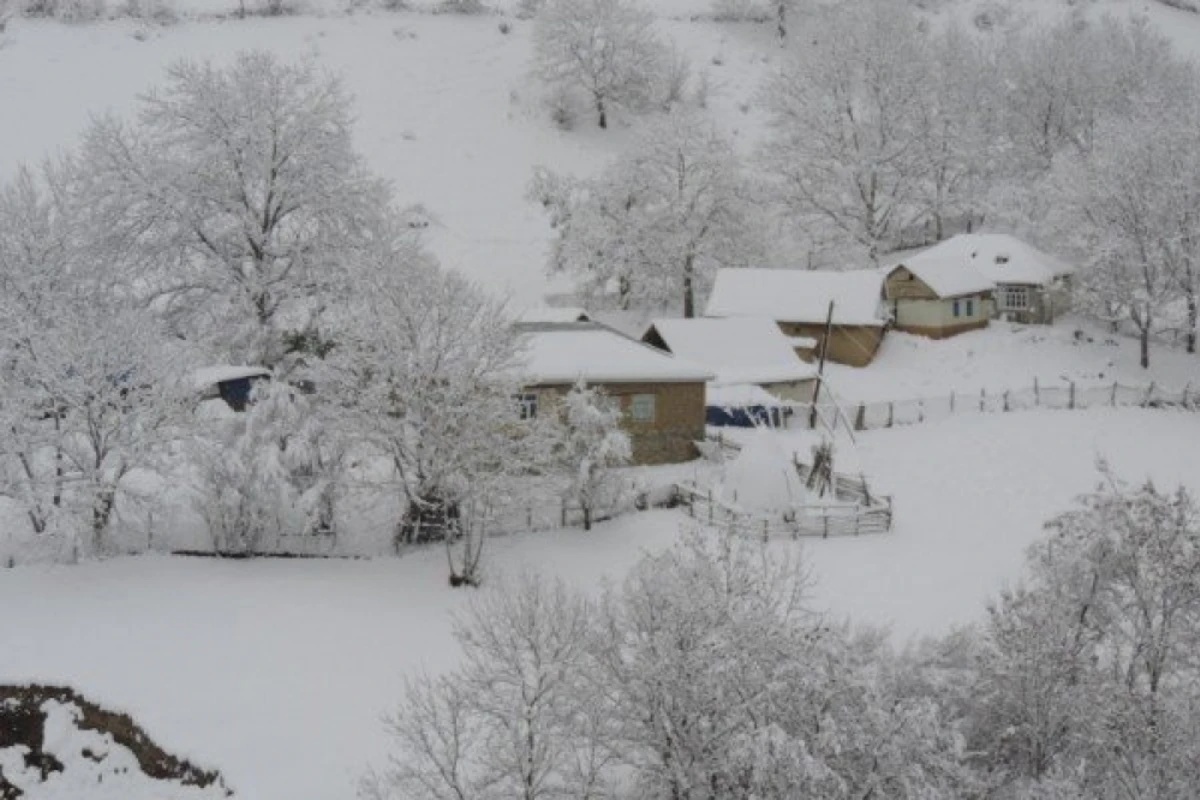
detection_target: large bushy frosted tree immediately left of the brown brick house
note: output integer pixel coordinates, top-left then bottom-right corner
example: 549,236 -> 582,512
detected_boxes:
328,248 -> 548,583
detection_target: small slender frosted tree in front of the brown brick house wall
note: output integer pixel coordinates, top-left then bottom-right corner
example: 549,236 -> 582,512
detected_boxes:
560,381 -> 632,530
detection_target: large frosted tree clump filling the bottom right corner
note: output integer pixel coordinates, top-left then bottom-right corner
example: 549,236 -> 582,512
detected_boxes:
972,465 -> 1200,799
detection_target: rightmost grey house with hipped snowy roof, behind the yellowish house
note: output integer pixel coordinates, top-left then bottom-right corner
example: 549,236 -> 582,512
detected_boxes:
897,234 -> 1074,325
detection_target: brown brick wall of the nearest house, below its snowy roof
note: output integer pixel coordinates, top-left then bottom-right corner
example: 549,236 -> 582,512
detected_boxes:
532,383 -> 704,465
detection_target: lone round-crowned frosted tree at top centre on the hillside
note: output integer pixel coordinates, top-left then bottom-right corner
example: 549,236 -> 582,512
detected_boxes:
533,0 -> 671,128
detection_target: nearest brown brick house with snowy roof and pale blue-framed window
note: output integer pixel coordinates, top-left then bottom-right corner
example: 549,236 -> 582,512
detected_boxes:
516,323 -> 714,464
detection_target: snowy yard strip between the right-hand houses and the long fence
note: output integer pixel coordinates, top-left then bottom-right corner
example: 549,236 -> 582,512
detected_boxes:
826,318 -> 1200,404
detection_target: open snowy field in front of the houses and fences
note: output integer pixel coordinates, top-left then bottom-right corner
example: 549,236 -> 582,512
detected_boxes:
0,410 -> 1200,800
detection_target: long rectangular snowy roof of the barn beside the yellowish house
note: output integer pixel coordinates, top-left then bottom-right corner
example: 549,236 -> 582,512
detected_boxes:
706,269 -> 884,326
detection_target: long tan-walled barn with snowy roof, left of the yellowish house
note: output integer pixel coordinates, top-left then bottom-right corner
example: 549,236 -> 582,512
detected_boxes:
704,269 -> 887,367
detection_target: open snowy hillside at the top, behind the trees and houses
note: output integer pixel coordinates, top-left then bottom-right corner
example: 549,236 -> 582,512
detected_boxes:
7,0 -> 1200,307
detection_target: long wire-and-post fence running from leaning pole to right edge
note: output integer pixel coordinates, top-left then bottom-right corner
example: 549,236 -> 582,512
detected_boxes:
788,381 -> 1200,431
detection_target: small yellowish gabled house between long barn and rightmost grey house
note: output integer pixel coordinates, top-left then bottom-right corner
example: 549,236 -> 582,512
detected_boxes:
884,247 -> 992,339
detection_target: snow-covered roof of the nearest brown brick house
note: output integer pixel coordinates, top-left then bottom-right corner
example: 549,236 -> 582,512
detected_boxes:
517,323 -> 713,385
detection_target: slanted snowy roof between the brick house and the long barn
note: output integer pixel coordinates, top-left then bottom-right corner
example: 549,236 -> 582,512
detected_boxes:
642,317 -> 817,385
